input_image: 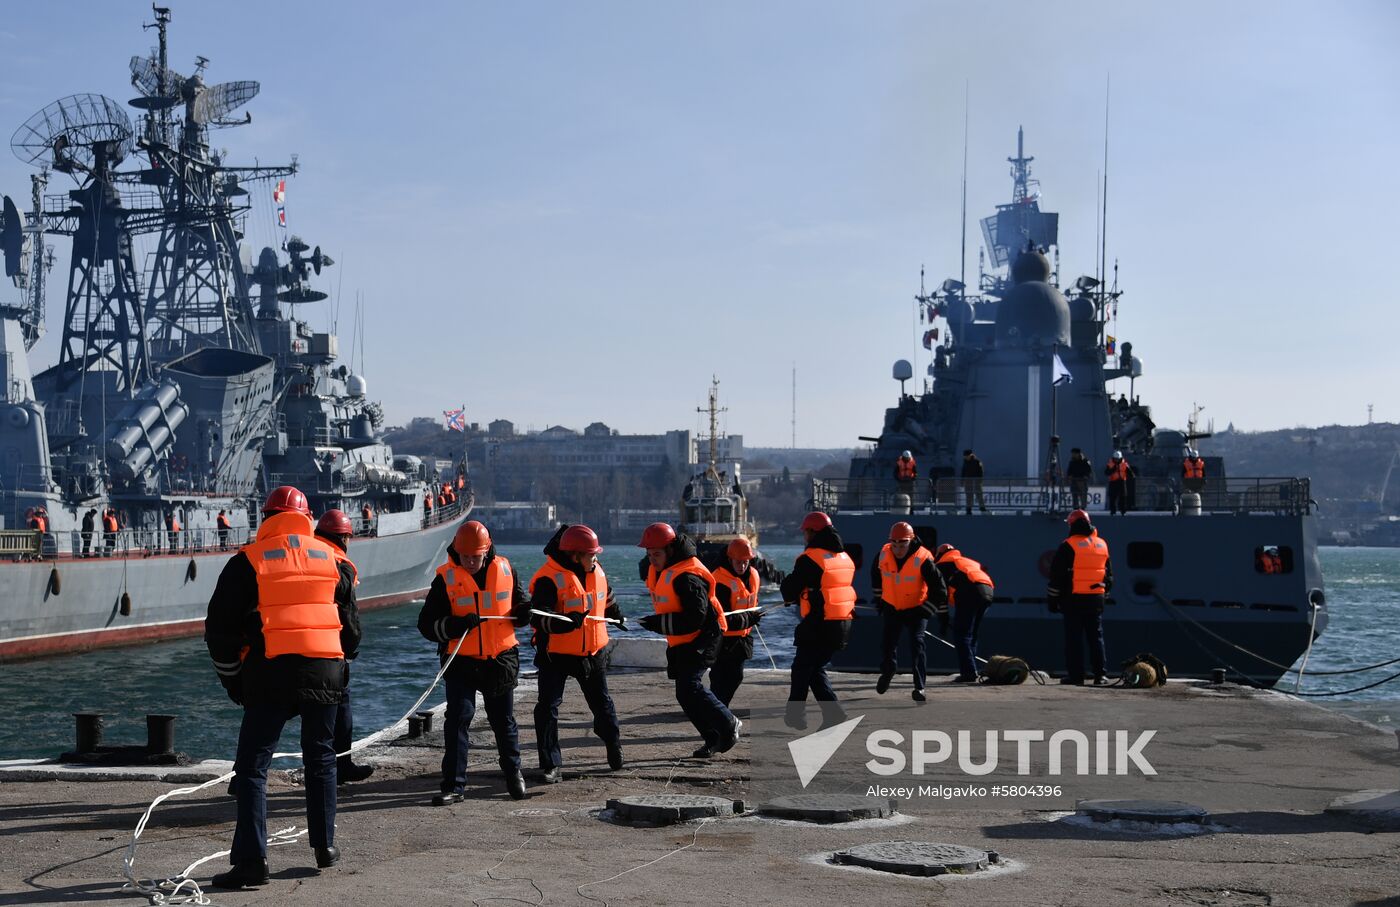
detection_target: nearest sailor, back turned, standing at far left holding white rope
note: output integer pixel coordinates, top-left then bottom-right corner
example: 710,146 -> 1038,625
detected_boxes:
204,486 -> 360,887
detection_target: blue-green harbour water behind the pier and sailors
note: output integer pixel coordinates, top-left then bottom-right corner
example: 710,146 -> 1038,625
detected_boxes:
0,546 -> 1400,759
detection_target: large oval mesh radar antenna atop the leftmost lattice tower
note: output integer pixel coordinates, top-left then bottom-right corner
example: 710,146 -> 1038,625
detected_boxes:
10,94 -> 132,172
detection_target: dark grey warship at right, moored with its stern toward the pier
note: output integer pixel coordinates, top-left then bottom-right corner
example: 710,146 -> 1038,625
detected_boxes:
813,125 -> 1327,686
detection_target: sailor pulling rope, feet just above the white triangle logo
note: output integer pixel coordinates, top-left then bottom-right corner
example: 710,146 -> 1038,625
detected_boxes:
780,511 -> 855,728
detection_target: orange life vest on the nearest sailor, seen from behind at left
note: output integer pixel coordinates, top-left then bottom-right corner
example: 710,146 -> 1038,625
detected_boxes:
244,514 -> 344,658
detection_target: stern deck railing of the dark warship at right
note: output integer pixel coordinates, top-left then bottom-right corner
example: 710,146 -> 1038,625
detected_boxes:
811,476 -> 1316,516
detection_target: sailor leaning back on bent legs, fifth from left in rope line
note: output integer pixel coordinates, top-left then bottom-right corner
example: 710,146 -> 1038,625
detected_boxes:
637,523 -> 739,759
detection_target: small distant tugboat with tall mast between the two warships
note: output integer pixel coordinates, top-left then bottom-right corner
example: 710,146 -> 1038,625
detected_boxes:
679,378 -> 783,584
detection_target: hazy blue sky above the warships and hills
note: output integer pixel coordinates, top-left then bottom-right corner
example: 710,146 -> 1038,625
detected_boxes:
0,0 -> 1400,447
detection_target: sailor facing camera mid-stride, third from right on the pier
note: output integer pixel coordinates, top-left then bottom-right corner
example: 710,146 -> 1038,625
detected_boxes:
871,522 -> 948,703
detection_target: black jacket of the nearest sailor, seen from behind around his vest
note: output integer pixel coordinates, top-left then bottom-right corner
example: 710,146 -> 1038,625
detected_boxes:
204,551 -> 360,707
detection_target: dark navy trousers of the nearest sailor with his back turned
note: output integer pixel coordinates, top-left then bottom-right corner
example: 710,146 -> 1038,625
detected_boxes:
228,703 -> 336,864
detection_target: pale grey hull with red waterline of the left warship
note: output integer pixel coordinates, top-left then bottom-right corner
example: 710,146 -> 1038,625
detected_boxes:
0,514 -> 458,661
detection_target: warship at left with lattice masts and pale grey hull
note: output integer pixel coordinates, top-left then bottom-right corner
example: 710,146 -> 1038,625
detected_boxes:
0,7 -> 472,661
